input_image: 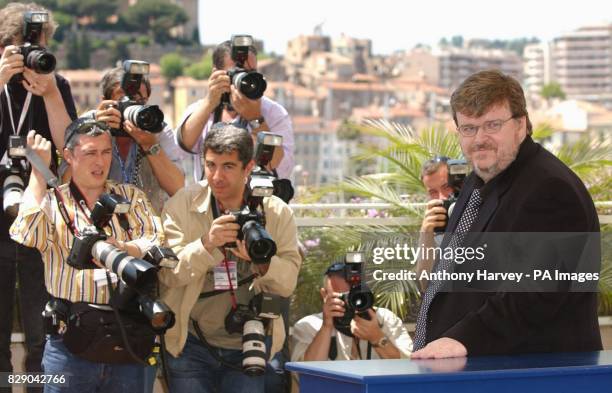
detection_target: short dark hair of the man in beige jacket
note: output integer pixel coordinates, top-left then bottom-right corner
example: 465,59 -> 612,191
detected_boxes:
203,122 -> 254,167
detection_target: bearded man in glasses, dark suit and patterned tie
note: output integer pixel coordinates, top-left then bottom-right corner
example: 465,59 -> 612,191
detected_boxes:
412,71 -> 602,358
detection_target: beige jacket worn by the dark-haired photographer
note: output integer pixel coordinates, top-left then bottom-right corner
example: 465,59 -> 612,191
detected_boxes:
160,181 -> 302,356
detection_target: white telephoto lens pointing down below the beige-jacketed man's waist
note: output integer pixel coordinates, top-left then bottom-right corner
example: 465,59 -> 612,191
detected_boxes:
242,319 -> 266,377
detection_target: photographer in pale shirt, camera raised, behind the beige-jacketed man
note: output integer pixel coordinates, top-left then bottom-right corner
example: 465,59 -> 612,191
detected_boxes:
177,36 -> 294,182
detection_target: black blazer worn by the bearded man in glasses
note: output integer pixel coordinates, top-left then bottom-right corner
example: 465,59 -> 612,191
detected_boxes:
426,136 -> 602,356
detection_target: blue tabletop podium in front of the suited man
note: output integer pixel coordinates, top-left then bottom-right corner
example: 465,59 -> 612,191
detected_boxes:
286,351 -> 612,393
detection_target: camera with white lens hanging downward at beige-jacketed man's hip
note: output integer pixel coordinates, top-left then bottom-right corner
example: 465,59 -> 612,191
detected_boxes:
225,292 -> 280,376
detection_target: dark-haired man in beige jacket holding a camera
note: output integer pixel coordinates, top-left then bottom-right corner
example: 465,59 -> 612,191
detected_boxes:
160,123 -> 301,393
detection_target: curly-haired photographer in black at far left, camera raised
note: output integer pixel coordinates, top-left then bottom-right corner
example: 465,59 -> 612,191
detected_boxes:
0,3 -> 77,391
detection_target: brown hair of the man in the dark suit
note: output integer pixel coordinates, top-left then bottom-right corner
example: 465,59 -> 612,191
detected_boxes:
450,70 -> 533,135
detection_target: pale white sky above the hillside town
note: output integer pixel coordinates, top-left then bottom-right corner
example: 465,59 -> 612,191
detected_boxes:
198,0 -> 612,54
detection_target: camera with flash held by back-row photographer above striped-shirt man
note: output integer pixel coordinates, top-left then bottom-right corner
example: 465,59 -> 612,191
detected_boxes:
111,60 -> 166,136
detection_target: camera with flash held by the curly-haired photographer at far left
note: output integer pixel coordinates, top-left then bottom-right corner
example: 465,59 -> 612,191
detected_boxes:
19,11 -> 57,79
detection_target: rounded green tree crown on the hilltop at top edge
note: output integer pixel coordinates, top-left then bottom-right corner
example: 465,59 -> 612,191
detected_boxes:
121,0 -> 188,43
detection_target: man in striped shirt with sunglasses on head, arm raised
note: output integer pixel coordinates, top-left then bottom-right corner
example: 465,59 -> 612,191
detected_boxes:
11,120 -> 163,392
